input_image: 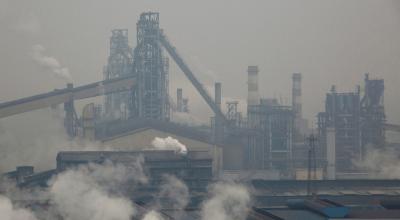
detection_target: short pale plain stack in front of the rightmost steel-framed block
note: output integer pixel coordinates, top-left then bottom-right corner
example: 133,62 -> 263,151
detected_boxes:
326,127 -> 336,180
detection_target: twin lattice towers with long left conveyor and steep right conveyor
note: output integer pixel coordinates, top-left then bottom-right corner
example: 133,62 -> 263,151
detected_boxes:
0,12 -> 228,139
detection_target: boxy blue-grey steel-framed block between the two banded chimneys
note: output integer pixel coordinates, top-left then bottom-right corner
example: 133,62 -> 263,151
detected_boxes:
246,100 -> 293,174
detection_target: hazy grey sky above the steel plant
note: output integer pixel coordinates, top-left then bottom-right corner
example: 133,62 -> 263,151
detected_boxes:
0,0 -> 400,123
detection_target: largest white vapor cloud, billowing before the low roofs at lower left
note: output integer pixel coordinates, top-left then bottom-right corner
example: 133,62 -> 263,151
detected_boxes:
50,162 -> 142,220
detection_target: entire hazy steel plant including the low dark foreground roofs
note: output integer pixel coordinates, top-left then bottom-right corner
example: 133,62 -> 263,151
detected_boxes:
0,12 -> 400,219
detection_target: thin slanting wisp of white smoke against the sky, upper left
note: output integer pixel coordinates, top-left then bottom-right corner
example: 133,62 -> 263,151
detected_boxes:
32,44 -> 72,82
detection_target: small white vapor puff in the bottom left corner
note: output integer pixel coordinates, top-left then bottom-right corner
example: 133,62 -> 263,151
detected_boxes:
0,195 -> 37,220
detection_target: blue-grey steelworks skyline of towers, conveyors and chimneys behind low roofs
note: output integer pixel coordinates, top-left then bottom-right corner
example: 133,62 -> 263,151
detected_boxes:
0,12 -> 400,179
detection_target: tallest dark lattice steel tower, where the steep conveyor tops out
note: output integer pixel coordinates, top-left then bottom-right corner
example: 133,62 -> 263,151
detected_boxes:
131,12 -> 170,120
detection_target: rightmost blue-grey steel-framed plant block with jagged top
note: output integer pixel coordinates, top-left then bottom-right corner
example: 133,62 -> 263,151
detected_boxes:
318,74 -> 385,172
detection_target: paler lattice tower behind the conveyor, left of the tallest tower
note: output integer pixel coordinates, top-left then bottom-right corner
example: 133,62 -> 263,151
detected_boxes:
104,29 -> 133,119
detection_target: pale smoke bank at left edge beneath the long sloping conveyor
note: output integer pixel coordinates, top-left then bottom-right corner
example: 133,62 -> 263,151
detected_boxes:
0,109 -> 105,173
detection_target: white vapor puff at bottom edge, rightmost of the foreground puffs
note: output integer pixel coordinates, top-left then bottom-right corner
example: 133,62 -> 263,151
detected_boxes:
202,183 -> 250,220
